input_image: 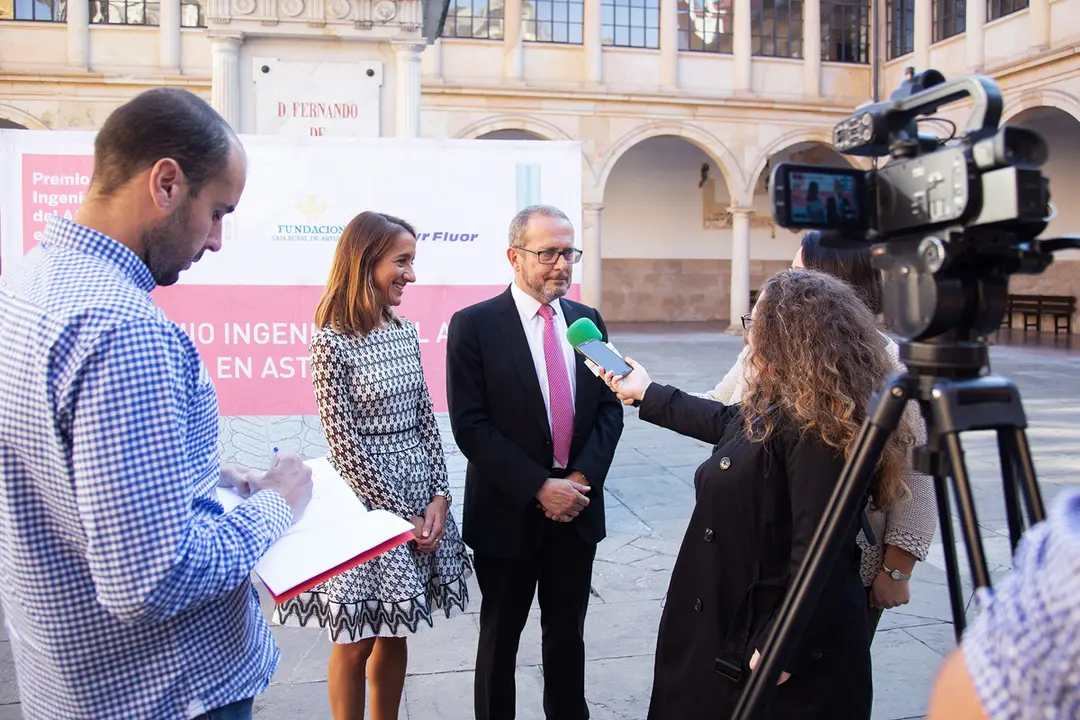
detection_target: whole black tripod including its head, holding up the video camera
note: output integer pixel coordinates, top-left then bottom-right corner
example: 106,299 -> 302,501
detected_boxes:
732,234 -> 1076,720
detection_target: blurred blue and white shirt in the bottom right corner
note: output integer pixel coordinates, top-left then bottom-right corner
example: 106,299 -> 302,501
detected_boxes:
962,490 -> 1080,720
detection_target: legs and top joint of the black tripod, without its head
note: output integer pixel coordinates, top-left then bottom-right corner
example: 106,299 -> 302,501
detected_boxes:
732,356 -> 1045,720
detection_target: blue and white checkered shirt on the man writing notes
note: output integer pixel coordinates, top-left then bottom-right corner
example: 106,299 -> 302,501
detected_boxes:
0,218 -> 292,720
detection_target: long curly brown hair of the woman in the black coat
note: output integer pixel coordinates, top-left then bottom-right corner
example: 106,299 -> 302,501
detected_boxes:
742,269 -> 915,510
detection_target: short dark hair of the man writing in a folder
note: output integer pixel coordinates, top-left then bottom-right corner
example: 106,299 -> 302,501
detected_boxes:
91,87 -> 237,198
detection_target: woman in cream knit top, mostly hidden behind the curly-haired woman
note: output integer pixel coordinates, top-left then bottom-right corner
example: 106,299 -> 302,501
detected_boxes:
701,231 -> 937,638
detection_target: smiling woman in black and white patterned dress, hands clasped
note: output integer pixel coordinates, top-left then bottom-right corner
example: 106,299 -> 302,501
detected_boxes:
274,212 -> 472,720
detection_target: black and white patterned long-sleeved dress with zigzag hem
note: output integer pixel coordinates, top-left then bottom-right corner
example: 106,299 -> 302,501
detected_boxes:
273,320 -> 472,642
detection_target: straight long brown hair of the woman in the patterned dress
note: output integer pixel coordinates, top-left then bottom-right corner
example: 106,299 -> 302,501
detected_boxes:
315,210 -> 416,335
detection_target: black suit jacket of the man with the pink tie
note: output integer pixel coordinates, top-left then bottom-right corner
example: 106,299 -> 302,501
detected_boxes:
446,288 -> 623,558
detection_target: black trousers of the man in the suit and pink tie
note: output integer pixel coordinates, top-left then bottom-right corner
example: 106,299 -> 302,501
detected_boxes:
473,520 -> 596,720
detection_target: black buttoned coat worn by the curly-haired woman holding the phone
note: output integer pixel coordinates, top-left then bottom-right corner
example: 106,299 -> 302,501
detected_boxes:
640,384 -> 873,720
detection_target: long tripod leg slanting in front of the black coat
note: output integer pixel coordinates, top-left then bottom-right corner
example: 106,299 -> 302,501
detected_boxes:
732,375 -> 914,720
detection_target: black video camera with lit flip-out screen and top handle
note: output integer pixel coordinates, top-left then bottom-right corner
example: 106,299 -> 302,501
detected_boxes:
770,70 -> 1050,242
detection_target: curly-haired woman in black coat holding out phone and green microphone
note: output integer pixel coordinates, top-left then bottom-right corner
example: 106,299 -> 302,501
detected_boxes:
604,270 -> 913,720
